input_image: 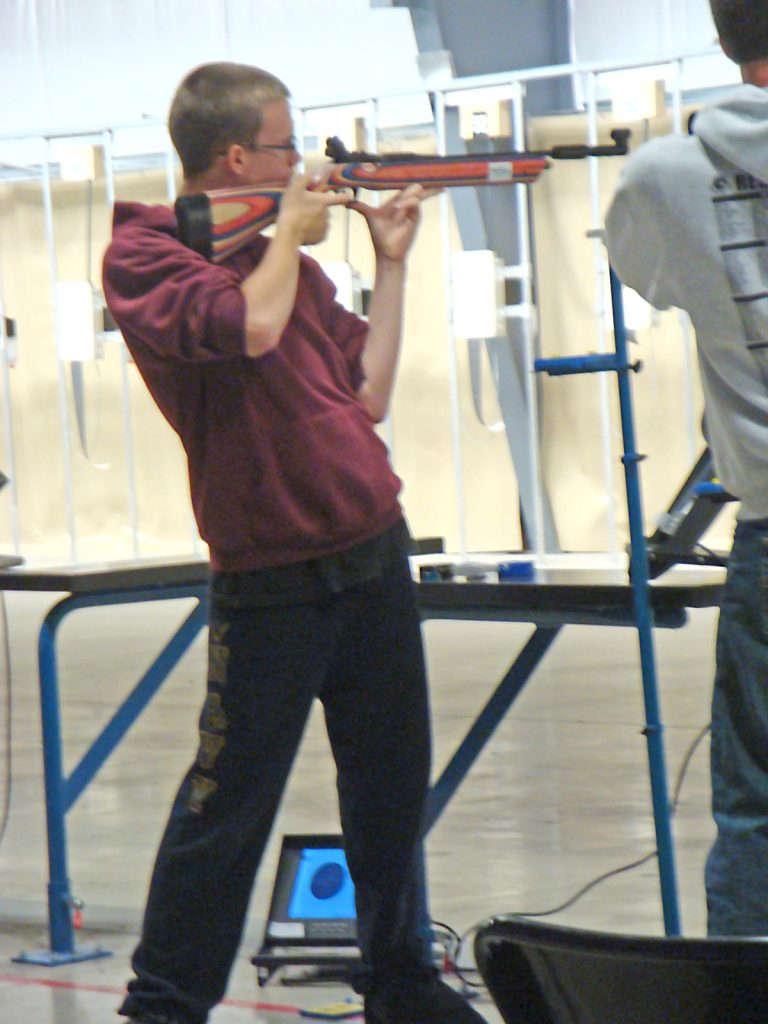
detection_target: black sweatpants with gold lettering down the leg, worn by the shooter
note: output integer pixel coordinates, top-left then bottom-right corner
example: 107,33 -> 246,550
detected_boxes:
120,558 -> 430,1024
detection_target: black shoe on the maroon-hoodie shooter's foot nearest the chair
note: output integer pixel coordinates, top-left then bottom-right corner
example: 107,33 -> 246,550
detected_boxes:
366,967 -> 486,1024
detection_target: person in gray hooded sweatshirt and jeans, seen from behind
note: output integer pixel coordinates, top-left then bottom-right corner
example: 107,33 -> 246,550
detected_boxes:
606,0 -> 768,935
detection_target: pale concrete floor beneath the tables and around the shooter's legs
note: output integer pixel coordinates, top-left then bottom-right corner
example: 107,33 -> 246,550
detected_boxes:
0,581 -> 716,1024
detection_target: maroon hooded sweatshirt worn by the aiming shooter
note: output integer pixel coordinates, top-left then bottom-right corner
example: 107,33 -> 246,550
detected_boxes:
103,203 -> 401,571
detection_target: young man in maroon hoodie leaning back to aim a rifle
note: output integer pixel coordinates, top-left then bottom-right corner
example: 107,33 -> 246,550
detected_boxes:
104,63 -> 481,1024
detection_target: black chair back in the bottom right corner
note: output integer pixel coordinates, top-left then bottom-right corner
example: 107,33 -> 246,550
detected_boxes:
474,914 -> 768,1024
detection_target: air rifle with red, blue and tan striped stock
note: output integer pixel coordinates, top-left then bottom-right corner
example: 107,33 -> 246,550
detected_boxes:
176,128 -> 630,263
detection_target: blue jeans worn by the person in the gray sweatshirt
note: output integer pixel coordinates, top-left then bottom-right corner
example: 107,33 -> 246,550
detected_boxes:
706,519 -> 768,935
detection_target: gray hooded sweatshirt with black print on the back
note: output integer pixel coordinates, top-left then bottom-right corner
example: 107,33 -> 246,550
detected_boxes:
606,85 -> 768,519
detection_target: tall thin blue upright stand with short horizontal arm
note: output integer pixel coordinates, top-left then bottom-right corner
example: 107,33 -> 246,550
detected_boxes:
536,269 -> 680,935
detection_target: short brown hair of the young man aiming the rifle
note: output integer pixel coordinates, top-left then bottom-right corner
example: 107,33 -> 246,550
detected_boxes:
168,61 -> 291,178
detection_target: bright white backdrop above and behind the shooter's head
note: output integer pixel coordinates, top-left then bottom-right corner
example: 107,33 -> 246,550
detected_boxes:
0,0 -> 422,136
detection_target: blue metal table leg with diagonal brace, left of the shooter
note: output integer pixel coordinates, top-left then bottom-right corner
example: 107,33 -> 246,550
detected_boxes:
13,585 -> 208,967
